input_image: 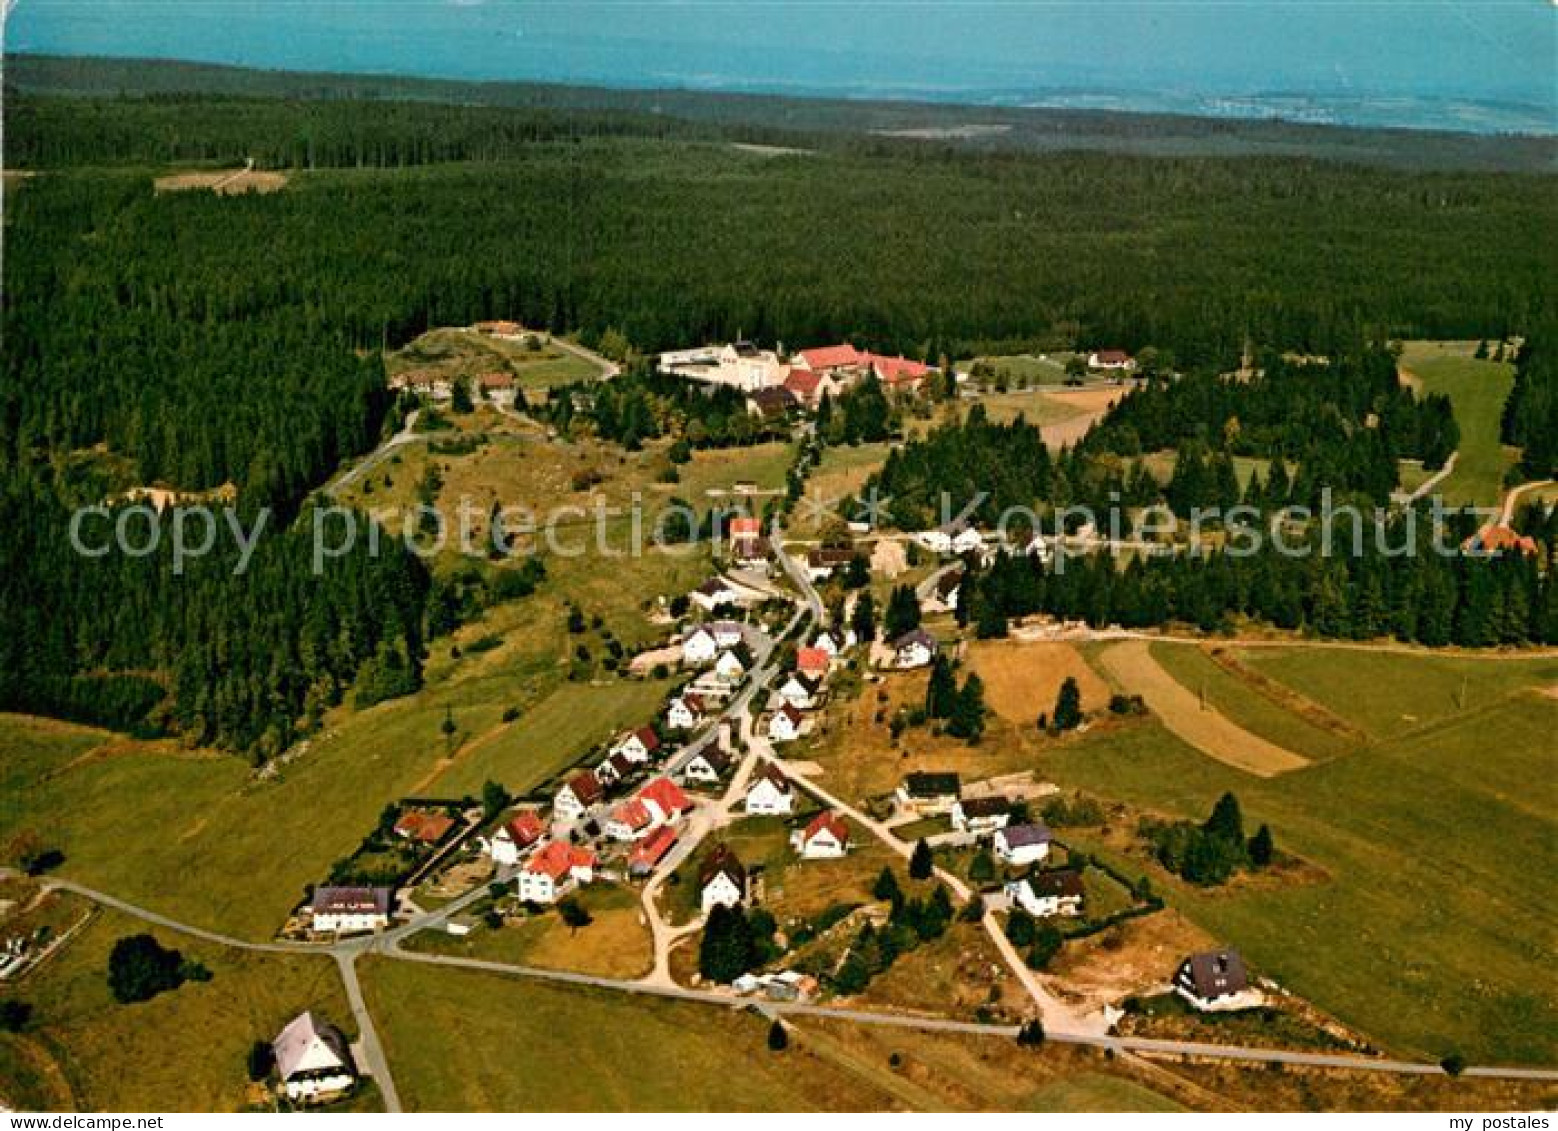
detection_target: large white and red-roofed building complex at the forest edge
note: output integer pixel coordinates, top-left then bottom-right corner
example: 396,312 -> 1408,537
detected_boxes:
659,340 -> 935,418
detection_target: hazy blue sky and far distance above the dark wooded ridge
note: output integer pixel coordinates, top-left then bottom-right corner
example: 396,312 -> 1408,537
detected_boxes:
5,0 -> 1558,136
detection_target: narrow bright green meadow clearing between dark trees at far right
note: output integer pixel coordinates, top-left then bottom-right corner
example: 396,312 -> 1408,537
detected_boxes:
1401,341 -> 1516,506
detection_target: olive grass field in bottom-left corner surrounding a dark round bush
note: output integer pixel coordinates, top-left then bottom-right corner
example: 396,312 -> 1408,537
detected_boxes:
0,911 -> 352,1111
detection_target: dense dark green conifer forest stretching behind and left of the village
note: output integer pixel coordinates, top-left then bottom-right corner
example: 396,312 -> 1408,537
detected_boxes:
0,88 -> 1552,754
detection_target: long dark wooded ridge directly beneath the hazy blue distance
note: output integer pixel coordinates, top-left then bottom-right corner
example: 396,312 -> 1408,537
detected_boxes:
5,55 -> 1558,173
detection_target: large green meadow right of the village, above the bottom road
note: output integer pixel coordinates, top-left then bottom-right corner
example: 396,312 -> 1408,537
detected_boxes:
1045,653 -> 1558,1062
